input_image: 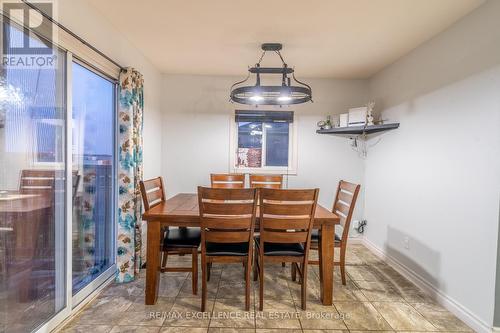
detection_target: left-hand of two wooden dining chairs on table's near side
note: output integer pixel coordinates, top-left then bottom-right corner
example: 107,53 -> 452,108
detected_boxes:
198,186 -> 257,312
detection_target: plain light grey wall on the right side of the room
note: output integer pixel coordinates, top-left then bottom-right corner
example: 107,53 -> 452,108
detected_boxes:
365,1 -> 500,331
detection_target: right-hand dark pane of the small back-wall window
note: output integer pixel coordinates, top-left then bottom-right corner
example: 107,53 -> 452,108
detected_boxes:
264,123 -> 289,167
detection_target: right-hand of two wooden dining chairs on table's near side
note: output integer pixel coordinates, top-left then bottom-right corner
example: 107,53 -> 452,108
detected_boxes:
254,188 -> 319,311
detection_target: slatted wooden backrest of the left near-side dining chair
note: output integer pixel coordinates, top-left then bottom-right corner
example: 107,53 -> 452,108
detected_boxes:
198,186 -> 257,246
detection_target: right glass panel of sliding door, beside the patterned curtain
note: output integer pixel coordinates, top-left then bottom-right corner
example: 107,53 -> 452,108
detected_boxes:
72,62 -> 116,295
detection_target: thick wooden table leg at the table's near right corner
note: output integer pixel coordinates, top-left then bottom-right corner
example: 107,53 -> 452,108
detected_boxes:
318,224 -> 335,305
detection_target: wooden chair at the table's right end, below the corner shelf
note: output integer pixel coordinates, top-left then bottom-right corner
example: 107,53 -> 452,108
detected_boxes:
309,180 -> 361,285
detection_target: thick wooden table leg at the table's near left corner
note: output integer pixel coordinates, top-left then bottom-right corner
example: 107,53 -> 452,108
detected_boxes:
146,221 -> 160,305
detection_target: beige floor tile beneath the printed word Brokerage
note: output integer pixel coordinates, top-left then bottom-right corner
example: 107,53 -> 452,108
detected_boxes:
296,302 -> 347,330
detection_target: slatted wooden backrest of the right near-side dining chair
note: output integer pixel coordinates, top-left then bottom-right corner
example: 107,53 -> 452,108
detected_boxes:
259,188 -> 319,245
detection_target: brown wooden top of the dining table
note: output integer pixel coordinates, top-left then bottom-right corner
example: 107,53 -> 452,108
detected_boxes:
142,193 -> 340,227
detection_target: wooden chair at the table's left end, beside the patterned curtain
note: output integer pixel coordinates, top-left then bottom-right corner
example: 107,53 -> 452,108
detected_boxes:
140,177 -> 201,295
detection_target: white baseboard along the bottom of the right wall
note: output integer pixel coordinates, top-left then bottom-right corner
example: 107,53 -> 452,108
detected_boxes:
362,238 -> 490,333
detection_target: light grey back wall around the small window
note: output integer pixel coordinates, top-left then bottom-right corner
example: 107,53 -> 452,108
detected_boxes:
162,74 -> 367,222
